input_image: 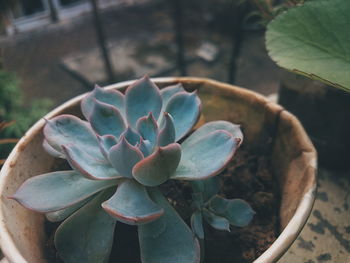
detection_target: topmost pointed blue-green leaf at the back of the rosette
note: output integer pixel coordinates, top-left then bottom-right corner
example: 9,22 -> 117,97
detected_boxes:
125,77 -> 162,128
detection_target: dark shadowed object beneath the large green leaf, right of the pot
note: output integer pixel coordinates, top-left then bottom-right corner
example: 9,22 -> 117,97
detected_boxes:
279,72 -> 350,170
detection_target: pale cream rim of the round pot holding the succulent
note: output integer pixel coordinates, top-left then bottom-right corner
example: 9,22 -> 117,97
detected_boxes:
0,77 -> 317,263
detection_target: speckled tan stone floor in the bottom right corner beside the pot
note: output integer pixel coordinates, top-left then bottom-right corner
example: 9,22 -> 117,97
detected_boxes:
279,169 -> 350,263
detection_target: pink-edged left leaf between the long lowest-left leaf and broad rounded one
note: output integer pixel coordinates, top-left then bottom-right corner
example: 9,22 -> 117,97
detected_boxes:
62,145 -> 122,180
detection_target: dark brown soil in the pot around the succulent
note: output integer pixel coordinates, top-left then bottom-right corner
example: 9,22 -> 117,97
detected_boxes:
47,144 -> 280,263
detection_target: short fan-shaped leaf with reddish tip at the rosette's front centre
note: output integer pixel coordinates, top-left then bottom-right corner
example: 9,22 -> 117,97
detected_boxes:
102,179 -> 164,225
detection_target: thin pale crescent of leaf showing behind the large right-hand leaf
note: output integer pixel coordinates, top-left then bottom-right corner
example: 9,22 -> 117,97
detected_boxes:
181,121 -> 243,148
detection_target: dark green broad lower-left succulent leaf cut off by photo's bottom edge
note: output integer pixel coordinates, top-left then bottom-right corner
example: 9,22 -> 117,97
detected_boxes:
54,189 -> 116,263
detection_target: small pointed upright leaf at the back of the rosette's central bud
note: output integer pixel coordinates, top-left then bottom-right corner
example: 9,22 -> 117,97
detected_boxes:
136,113 -> 158,149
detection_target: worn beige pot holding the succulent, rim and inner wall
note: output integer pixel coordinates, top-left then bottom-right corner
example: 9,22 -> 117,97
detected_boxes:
0,78 -> 316,263
